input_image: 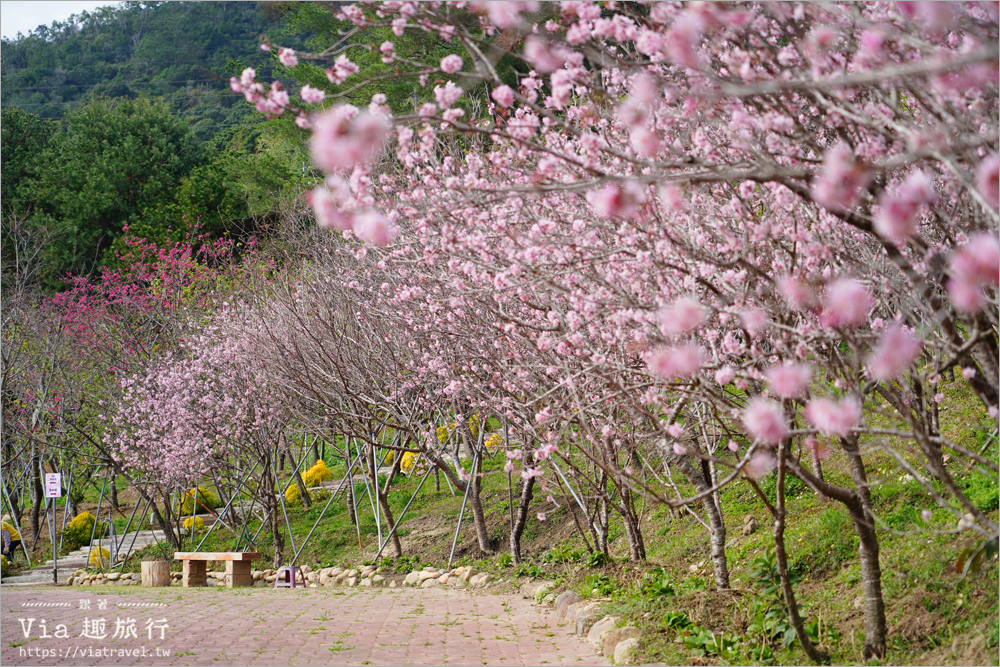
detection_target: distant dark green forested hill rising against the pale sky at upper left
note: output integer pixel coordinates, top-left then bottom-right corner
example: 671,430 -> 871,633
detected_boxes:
2,2 -> 297,141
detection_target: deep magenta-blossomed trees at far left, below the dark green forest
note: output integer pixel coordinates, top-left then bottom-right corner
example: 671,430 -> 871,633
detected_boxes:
3,218 -> 246,548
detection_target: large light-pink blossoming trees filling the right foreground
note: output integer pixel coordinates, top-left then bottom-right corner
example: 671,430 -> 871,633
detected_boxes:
223,2 -> 1000,660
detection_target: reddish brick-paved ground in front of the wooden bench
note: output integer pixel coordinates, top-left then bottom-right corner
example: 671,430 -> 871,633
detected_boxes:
0,586 -> 609,665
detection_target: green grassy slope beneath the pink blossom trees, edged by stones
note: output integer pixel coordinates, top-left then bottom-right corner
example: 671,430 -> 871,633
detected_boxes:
11,376 -> 998,664
